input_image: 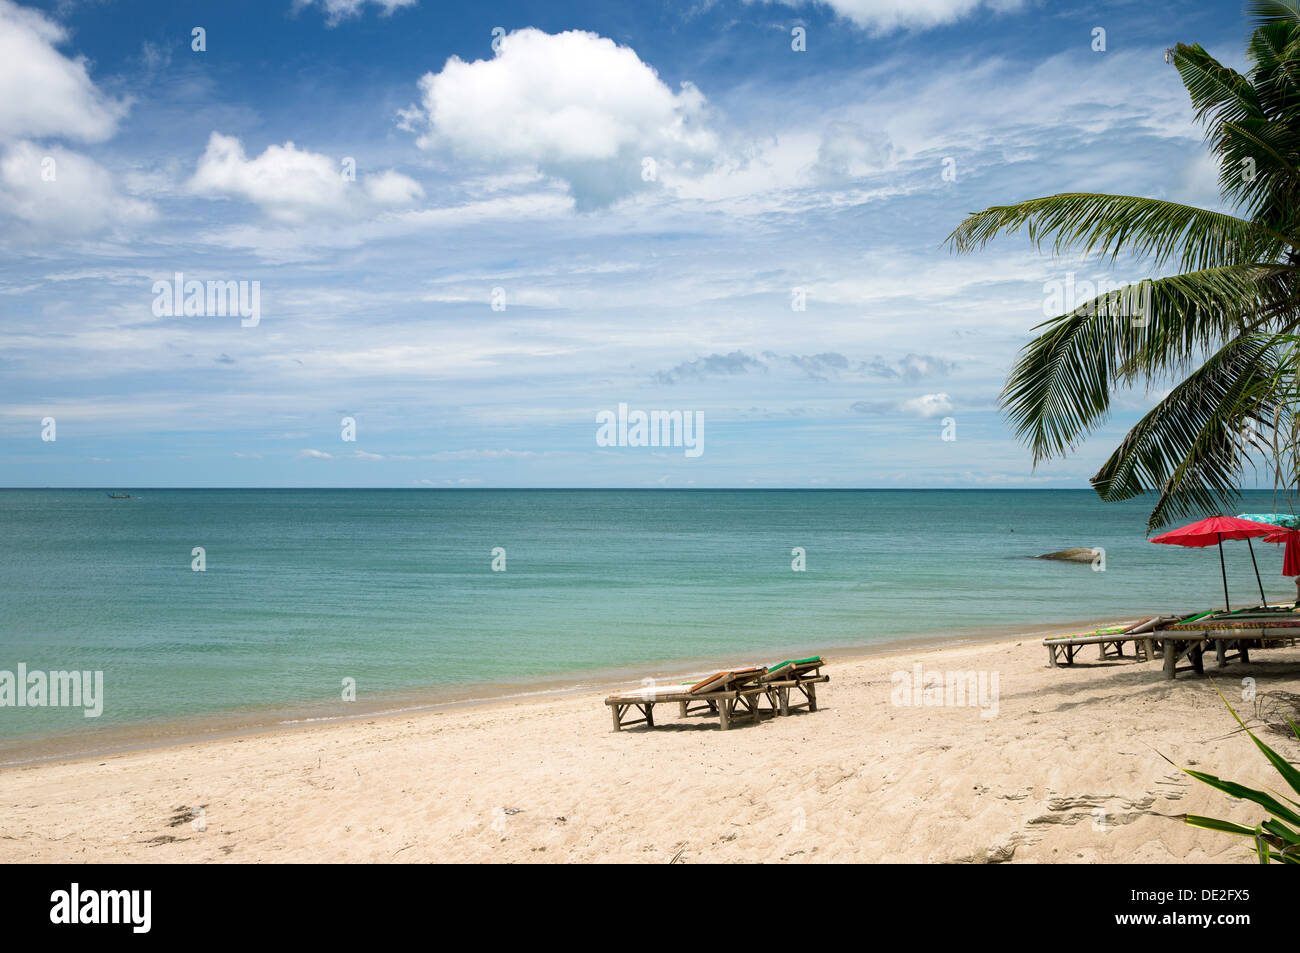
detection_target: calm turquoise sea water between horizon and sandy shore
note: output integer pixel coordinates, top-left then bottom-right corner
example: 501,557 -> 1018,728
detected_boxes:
0,490 -> 1295,740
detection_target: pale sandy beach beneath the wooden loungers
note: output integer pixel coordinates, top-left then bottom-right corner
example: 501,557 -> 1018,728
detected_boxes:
0,637 -> 1300,863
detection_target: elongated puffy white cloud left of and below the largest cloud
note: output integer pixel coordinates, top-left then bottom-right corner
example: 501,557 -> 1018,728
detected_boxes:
189,133 -> 424,224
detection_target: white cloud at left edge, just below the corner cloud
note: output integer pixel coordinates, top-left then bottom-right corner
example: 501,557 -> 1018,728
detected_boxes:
0,142 -> 153,235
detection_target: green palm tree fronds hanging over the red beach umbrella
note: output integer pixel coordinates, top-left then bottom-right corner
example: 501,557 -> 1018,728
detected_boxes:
948,0 -> 1300,530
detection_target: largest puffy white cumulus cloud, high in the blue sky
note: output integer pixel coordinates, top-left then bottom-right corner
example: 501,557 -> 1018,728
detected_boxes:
399,27 -> 716,209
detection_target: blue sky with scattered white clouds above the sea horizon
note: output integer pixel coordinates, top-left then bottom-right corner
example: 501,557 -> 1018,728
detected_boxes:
0,0 -> 1248,488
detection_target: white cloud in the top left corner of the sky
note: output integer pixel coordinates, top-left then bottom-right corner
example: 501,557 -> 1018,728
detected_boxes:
0,0 -> 126,142
